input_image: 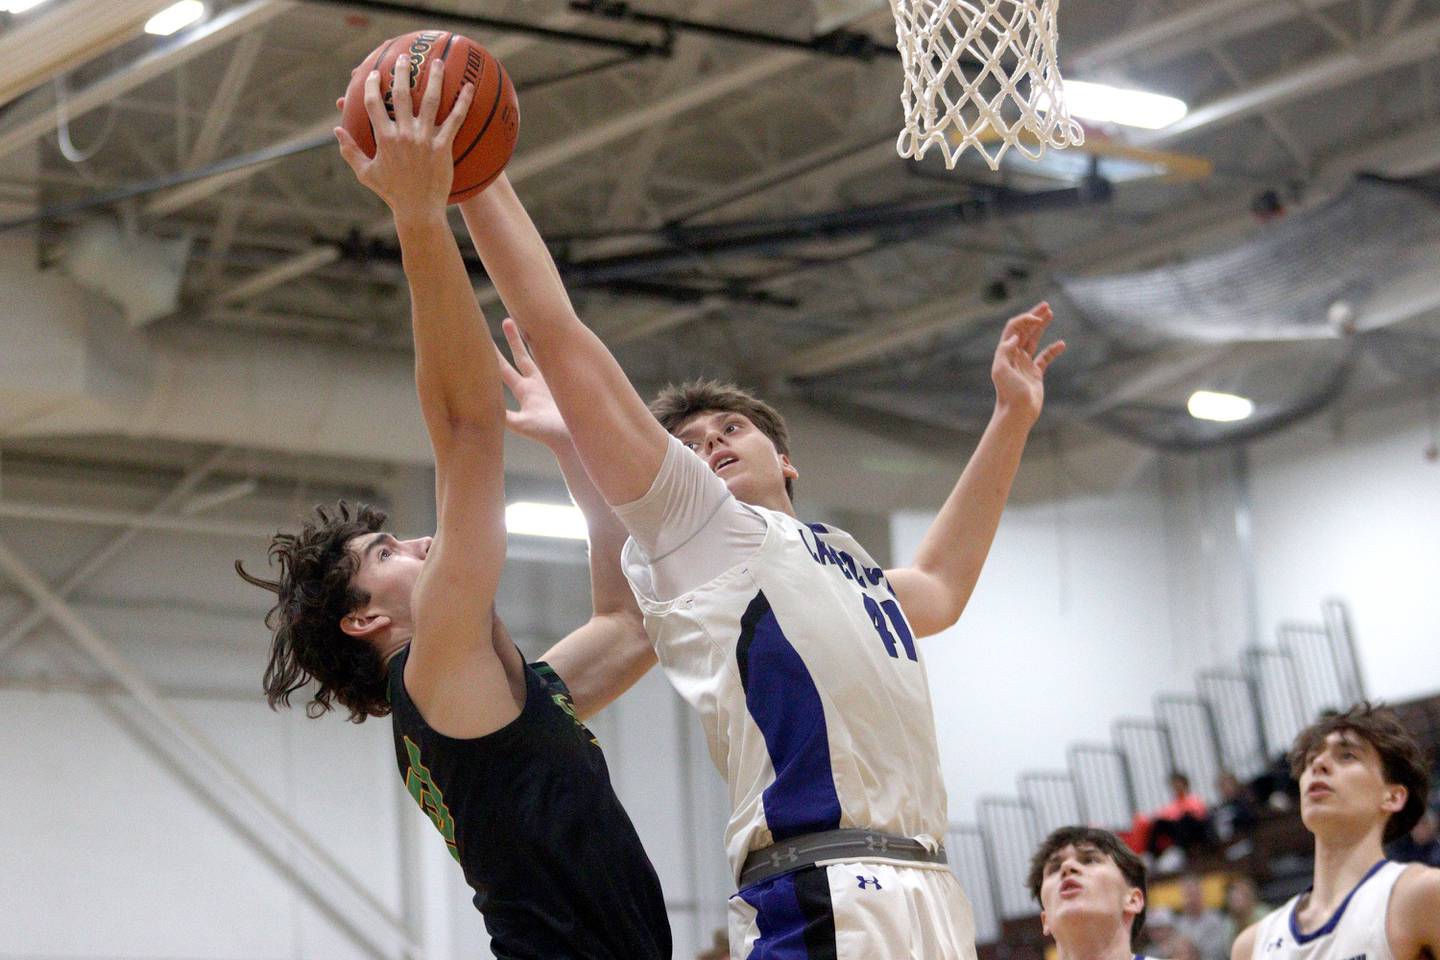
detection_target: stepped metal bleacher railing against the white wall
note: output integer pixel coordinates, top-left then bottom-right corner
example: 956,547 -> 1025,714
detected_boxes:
948,600 -> 1364,944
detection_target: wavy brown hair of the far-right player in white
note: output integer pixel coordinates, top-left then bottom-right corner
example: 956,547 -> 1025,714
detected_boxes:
1290,699 -> 1430,843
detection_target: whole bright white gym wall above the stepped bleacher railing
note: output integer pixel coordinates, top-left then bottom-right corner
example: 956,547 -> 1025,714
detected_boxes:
891,403 -> 1440,820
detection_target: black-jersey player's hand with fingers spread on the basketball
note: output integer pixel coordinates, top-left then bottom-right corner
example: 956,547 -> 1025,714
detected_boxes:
336,55 -> 475,217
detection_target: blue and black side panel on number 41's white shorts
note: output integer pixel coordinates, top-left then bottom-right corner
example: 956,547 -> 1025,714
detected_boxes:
740,866 -> 838,960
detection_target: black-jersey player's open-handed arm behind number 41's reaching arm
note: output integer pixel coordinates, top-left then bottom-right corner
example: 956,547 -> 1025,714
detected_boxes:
500,320 -> 655,720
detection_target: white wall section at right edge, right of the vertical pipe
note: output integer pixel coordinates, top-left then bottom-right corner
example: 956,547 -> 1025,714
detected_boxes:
1251,402 -> 1440,701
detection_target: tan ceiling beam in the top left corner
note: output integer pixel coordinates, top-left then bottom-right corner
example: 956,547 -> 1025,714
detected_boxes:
0,0 -> 170,105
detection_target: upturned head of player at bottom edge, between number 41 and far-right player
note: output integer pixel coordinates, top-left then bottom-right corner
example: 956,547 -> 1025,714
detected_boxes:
1027,826 -> 1145,960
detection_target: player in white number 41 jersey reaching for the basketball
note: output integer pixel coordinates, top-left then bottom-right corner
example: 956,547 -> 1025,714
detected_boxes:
462,177 -> 1064,960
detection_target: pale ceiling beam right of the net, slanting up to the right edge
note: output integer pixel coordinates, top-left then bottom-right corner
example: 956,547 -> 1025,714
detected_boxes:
1130,17 -> 1440,147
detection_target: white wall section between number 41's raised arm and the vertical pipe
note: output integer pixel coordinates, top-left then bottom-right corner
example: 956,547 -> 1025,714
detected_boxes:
891,456 -> 1189,820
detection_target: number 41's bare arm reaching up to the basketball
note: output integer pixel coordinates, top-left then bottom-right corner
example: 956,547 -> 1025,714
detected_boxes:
461,176 -> 668,504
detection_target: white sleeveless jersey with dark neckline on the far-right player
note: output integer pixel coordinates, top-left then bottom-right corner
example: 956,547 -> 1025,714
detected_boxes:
1251,861 -> 1408,960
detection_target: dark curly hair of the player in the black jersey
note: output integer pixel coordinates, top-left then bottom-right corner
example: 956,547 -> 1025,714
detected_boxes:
235,499 -> 390,724
